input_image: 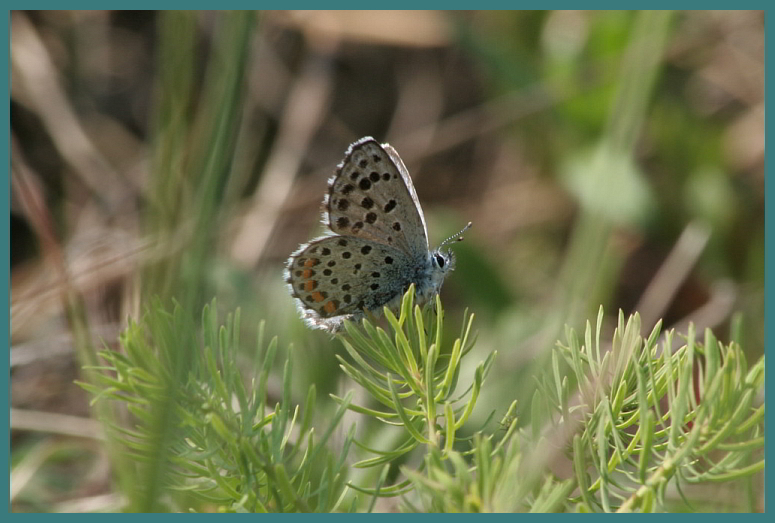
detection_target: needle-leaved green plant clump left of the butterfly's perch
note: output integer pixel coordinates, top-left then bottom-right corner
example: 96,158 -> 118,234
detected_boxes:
80,300 -> 352,512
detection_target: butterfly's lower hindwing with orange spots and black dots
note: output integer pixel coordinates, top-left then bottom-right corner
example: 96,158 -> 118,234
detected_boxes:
285,236 -> 411,330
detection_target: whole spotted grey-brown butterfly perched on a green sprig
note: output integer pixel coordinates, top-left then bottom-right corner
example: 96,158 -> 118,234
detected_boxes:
284,136 -> 471,333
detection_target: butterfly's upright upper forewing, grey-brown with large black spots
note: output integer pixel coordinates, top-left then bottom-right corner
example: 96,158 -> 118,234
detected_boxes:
324,137 -> 428,262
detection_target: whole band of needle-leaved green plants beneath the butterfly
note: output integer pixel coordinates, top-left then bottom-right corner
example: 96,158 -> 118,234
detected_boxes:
82,288 -> 764,512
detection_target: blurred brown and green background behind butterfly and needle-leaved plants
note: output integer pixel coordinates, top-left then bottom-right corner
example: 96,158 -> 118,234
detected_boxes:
10,11 -> 764,511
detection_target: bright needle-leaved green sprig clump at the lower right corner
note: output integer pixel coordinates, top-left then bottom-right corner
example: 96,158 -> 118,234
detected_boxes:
533,307 -> 764,512
